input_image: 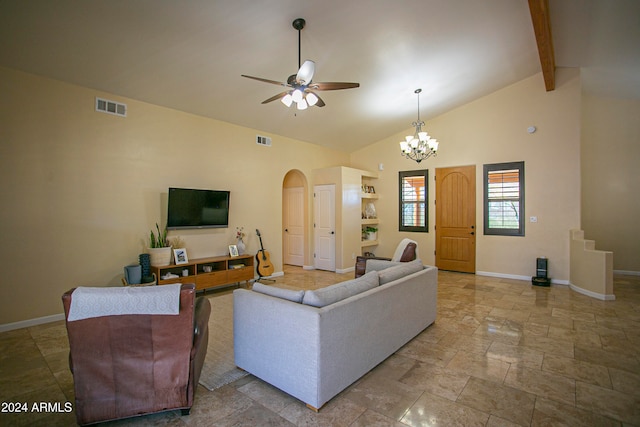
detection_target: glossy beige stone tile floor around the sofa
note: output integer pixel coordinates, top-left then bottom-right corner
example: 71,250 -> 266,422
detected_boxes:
0,267 -> 640,427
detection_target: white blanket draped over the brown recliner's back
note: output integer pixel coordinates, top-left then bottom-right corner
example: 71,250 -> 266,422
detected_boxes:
67,283 -> 182,322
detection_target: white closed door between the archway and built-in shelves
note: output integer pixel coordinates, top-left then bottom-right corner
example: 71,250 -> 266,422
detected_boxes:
313,185 -> 336,271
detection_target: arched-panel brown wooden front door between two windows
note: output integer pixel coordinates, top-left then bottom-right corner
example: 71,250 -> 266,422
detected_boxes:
436,166 -> 477,273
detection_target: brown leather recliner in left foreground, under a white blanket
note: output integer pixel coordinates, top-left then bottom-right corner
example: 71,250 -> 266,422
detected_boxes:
62,284 -> 211,425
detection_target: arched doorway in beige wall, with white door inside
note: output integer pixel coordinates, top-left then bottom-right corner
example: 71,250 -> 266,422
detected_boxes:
282,169 -> 309,267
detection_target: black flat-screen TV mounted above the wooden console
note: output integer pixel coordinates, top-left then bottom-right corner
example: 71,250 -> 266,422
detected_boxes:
167,188 -> 229,230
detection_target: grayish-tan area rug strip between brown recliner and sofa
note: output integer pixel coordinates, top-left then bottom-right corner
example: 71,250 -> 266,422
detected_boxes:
200,293 -> 247,391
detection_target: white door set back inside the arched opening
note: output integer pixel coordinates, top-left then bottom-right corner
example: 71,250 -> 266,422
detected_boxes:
283,187 -> 304,266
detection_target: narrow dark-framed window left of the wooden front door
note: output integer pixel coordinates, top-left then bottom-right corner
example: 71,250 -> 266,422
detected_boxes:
399,169 -> 429,233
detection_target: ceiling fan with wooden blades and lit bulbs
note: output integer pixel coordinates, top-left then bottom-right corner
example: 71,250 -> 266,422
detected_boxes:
242,18 -> 360,110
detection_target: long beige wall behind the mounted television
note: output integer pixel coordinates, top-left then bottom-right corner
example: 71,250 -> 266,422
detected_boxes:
0,68 -> 349,325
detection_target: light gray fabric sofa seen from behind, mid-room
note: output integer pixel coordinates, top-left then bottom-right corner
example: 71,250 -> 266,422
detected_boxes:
233,260 -> 438,410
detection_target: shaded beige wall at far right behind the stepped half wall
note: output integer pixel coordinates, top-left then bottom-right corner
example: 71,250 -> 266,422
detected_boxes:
582,95 -> 640,272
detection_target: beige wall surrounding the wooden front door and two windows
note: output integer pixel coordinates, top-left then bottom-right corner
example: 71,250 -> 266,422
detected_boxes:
351,69 -> 581,282
